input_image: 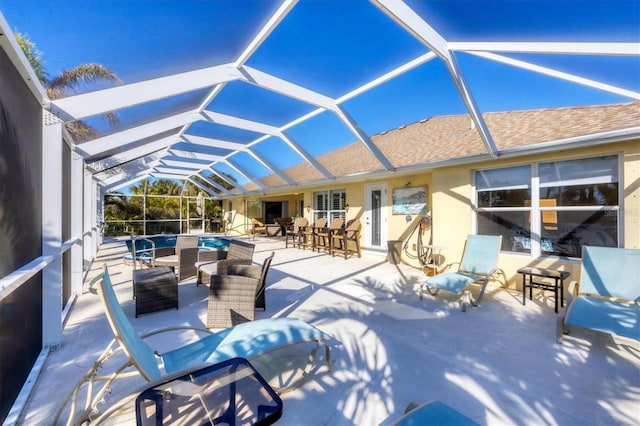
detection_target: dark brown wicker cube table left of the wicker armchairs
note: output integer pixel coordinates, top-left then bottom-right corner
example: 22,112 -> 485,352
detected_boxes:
133,266 -> 178,318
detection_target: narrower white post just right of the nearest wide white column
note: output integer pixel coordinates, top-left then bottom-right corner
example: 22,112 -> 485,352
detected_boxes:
70,152 -> 84,295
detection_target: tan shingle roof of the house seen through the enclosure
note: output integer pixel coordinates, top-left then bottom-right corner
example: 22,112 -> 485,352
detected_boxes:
268,102 -> 640,189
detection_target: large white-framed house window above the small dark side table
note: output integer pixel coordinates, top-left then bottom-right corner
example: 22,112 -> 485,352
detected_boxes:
475,155 -> 620,257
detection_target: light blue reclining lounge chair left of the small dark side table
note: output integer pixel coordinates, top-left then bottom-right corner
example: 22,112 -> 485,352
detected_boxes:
420,235 -> 502,312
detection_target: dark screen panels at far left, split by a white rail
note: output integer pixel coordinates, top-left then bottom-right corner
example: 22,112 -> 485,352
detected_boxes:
0,45 -> 42,421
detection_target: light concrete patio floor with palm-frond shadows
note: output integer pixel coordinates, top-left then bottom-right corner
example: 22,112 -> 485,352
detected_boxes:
20,237 -> 640,425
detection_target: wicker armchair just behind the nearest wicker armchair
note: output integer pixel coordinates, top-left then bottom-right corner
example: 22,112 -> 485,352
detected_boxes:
194,240 -> 256,285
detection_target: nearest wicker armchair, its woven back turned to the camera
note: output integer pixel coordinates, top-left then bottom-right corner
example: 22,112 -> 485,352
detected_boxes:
207,252 -> 275,328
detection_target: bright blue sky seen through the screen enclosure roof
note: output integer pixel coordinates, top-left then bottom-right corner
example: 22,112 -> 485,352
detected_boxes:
0,0 -> 640,188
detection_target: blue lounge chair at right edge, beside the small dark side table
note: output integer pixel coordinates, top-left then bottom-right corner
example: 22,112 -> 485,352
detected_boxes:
556,246 -> 640,343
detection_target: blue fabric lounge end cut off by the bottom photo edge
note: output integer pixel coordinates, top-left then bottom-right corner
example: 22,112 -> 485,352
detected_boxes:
394,401 -> 478,426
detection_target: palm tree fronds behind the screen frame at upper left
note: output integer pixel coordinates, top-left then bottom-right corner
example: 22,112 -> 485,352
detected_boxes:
16,33 -> 122,142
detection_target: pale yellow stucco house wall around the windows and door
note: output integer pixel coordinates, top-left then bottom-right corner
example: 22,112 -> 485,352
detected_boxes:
225,141 -> 640,294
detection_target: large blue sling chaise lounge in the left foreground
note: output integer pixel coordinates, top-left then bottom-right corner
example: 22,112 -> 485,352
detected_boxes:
54,265 -> 331,424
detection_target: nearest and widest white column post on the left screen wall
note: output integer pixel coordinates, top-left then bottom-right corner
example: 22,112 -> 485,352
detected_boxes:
42,110 -> 63,350
